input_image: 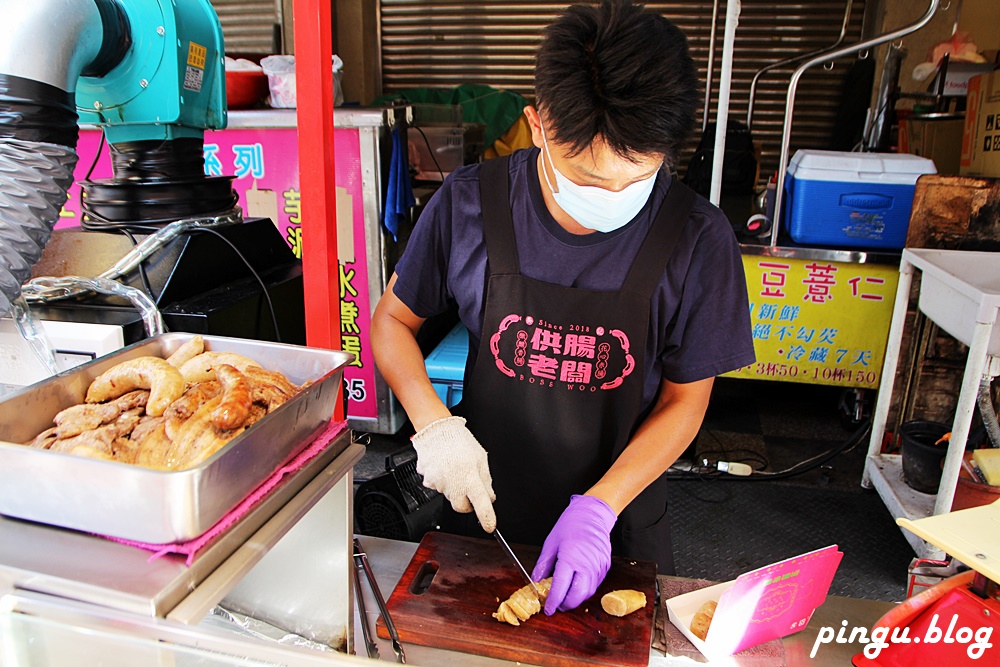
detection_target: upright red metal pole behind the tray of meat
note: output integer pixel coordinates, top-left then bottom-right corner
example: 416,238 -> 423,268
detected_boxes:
293,0 -> 345,420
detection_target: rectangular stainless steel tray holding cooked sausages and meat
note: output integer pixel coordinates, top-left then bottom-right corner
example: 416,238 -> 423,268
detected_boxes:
0,333 -> 353,544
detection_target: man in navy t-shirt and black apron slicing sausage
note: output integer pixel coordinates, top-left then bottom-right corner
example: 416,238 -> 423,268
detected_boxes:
372,0 -> 754,614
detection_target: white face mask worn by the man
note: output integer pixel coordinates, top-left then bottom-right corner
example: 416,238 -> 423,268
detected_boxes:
541,121 -> 656,234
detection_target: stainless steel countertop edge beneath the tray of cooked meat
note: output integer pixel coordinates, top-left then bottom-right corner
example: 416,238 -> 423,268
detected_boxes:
0,430 -> 364,623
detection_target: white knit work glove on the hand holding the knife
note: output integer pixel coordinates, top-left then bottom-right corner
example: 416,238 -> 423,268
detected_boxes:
412,417 -> 497,533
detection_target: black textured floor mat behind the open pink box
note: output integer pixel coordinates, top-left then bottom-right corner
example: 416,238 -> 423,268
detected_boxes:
669,481 -> 913,601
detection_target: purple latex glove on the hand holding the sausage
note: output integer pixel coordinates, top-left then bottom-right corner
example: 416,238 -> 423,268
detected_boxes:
531,496 -> 618,616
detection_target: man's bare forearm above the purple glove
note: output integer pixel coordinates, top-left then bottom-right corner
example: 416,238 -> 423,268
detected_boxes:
587,378 -> 714,514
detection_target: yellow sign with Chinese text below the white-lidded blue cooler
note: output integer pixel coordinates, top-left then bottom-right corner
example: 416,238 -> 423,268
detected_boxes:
726,255 -> 899,389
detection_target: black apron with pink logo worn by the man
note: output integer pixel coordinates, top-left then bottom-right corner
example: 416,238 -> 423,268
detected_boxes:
443,157 -> 695,574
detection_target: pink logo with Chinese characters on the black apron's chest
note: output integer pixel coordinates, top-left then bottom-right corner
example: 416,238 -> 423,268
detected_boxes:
490,314 -> 635,391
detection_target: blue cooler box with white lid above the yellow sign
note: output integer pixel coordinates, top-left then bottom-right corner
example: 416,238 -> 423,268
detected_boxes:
783,150 -> 937,250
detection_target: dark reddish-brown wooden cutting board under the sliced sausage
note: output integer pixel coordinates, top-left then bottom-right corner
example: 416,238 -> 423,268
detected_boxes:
377,532 -> 656,667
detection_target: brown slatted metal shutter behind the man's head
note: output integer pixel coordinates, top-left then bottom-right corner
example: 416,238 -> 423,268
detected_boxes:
380,0 -> 865,176
